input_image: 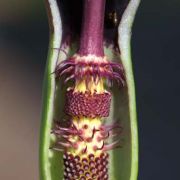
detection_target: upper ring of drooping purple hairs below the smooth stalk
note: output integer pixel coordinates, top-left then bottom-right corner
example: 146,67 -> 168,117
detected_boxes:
55,58 -> 125,86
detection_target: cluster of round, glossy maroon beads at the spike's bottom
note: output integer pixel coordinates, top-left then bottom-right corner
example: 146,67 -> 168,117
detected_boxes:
63,153 -> 109,180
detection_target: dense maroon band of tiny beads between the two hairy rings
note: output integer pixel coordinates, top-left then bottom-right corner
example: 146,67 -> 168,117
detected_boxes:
65,90 -> 111,118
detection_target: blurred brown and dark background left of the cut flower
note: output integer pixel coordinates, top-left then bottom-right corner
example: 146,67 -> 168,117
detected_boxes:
0,0 -> 49,180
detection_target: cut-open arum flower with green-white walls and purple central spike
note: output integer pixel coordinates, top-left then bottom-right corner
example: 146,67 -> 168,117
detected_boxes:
40,0 -> 139,180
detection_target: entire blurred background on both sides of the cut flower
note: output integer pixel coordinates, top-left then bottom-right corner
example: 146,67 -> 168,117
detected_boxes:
0,0 -> 180,180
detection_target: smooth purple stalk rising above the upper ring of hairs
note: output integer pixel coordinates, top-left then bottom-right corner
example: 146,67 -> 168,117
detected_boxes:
78,0 -> 106,56
